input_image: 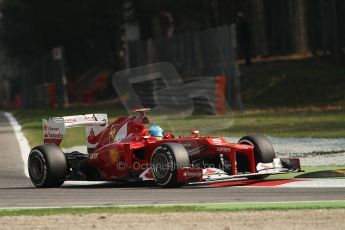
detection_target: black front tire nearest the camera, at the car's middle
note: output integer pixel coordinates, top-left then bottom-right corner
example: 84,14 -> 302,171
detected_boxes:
151,143 -> 190,187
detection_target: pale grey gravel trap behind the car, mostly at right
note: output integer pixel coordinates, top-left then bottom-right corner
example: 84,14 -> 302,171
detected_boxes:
64,137 -> 345,166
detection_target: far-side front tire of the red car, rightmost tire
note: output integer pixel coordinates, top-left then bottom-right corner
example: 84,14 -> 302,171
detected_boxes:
238,134 -> 276,179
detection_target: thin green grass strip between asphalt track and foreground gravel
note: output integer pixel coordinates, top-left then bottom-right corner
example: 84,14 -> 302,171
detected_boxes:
0,201 -> 345,216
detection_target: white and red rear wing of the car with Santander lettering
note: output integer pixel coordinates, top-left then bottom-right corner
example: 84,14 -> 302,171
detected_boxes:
42,114 -> 108,150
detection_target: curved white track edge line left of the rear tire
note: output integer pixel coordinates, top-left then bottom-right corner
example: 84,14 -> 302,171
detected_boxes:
4,112 -> 31,177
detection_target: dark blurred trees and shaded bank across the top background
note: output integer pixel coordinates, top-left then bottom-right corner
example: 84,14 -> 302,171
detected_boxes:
0,0 -> 345,109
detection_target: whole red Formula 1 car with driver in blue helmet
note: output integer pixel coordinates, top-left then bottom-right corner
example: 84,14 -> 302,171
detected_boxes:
28,109 -> 300,187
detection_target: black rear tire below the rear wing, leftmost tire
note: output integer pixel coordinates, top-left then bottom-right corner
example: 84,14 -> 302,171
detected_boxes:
28,145 -> 68,188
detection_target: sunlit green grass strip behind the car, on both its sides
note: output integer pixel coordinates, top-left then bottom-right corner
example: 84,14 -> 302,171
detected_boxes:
13,108 -> 345,147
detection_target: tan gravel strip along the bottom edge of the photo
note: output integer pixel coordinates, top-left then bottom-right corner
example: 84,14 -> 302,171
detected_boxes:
0,209 -> 345,230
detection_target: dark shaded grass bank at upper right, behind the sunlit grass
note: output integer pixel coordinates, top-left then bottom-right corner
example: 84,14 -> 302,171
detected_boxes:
241,59 -> 345,107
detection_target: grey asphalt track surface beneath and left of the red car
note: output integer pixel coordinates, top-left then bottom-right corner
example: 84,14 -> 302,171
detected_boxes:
0,112 -> 345,208
